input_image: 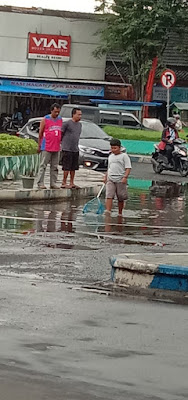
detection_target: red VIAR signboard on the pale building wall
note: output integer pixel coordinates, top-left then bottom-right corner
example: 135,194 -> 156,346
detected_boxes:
28,33 -> 71,61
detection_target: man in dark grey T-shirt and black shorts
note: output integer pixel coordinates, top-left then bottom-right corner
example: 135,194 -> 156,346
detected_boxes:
61,108 -> 82,188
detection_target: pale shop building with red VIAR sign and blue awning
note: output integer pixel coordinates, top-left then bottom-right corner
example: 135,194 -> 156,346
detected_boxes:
0,6 -> 106,116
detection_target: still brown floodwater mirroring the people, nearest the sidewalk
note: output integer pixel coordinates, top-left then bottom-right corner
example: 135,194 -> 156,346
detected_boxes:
0,181 -> 188,237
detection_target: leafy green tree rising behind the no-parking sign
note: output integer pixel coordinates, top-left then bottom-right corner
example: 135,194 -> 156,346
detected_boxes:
95,0 -> 188,99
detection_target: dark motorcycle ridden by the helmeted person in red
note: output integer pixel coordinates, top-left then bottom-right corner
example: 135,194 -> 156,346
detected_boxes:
151,138 -> 188,177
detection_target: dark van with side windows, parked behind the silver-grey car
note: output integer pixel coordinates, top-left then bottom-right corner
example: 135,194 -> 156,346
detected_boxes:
60,104 -> 142,129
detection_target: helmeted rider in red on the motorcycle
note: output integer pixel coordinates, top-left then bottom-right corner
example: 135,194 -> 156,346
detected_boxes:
158,117 -> 179,164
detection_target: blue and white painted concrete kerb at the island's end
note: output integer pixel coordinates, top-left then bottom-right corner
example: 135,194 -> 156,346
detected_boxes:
110,255 -> 188,292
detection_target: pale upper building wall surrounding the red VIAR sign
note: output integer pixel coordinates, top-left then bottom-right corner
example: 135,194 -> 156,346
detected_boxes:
0,11 -> 106,80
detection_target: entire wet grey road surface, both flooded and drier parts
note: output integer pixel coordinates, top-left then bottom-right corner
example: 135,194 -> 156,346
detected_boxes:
0,164 -> 188,400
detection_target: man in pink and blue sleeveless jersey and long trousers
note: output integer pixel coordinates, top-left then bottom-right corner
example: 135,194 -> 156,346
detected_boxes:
37,103 -> 62,189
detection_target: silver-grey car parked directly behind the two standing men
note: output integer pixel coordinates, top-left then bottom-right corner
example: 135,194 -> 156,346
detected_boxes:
18,117 -> 118,171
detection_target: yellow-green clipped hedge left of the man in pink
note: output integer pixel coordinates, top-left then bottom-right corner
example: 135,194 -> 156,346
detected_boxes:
0,134 -> 38,156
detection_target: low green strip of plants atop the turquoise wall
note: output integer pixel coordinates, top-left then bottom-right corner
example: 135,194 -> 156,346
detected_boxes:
103,125 -> 188,142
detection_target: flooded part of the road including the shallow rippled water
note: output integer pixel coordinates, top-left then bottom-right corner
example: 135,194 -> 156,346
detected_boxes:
0,180 -> 188,284
